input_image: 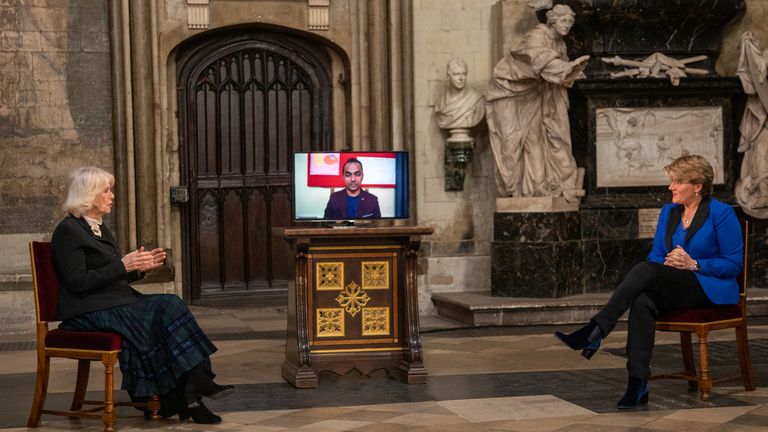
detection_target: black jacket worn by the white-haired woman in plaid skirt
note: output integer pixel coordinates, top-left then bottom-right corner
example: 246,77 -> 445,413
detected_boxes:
51,215 -> 144,319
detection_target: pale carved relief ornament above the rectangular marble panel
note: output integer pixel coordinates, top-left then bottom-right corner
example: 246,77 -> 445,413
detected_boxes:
601,52 -> 709,86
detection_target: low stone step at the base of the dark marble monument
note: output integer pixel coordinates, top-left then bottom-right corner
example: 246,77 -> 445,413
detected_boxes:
432,288 -> 768,327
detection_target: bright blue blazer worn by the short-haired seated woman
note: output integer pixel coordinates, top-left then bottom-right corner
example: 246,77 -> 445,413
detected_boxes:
648,199 -> 744,304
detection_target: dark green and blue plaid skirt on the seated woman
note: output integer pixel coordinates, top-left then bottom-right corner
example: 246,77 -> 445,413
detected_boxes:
59,294 -> 216,397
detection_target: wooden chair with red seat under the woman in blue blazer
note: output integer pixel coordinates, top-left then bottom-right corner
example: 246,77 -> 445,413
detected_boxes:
650,220 -> 755,400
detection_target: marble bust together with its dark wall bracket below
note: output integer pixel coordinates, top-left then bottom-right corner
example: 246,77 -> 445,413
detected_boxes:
435,58 -> 485,191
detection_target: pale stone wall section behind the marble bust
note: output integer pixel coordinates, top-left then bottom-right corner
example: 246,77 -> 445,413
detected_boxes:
413,0 -> 498,313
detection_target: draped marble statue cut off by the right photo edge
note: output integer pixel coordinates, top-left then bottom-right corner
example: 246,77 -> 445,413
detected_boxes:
735,32 -> 768,219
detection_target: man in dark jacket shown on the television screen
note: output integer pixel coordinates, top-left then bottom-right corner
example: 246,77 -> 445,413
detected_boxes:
323,158 -> 381,220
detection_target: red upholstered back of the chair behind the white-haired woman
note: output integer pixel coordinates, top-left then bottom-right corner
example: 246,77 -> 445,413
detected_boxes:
29,241 -> 59,323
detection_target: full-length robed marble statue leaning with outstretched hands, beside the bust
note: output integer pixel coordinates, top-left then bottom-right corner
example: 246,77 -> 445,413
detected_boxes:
486,5 -> 589,203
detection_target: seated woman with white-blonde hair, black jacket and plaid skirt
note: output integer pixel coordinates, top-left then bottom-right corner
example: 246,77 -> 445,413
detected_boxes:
51,167 -> 233,424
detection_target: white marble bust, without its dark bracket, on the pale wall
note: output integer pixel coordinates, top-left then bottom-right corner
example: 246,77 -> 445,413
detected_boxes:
435,58 -> 485,142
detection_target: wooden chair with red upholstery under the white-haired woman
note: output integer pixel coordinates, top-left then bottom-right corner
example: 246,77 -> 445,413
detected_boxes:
27,242 -> 160,432
